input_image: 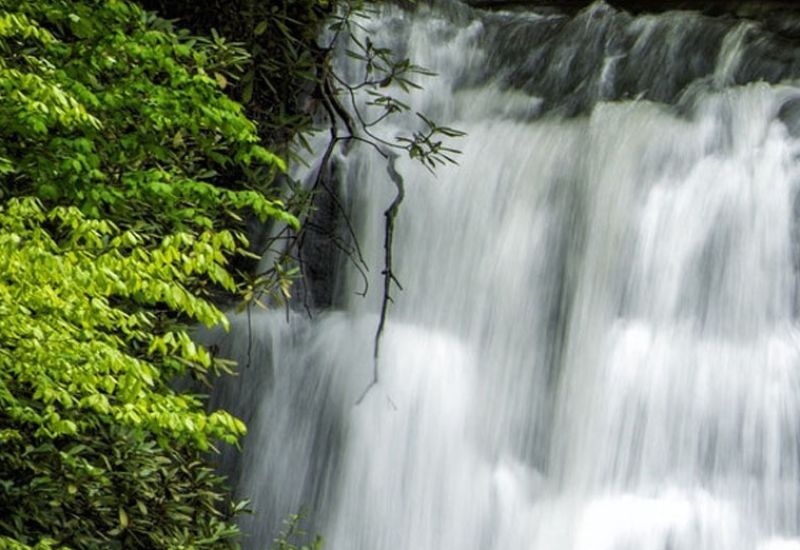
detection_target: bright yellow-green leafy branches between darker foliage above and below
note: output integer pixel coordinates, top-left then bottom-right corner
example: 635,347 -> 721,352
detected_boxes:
0,199 -> 244,450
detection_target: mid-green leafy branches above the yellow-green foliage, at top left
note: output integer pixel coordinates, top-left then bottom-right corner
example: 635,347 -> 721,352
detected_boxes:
0,0 -> 297,232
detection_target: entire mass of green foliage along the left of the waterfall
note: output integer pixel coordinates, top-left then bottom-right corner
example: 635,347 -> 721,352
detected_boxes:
0,0 -> 298,550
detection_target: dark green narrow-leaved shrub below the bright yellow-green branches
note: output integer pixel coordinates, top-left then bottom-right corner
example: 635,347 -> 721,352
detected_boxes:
0,427 -> 245,549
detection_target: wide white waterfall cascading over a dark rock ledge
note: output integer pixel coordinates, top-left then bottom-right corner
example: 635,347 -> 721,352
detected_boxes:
205,2 -> 800,550
